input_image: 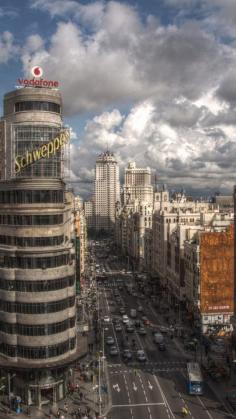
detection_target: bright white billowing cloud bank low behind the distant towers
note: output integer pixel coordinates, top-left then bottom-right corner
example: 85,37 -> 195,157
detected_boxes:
71,101 -> 236,199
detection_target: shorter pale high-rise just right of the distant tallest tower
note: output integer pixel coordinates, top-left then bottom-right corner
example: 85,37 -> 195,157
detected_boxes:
123,162 -> 153,205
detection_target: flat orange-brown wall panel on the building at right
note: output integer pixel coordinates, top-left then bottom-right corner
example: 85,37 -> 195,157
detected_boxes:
200,225 -> 234,313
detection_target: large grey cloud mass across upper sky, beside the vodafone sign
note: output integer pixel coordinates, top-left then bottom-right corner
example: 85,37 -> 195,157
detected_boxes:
23,0 -> 230,115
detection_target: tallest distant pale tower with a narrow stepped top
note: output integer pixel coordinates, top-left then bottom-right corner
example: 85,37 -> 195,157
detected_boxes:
94,151 -> 120,232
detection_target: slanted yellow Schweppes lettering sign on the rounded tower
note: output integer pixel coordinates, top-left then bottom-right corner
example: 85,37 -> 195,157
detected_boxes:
15,130 -> 70,174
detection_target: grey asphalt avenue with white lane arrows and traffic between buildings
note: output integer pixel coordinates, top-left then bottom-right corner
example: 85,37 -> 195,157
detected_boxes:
91,241 -> 235,419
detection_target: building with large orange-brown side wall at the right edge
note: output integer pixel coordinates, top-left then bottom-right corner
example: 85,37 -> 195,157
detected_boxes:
184,223 -> 234,333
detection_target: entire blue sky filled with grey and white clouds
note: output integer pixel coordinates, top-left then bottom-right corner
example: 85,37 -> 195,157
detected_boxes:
0,0 -> 236,197
